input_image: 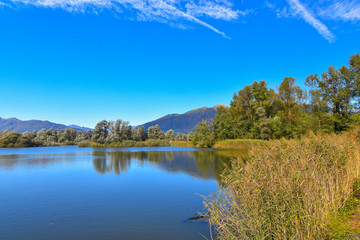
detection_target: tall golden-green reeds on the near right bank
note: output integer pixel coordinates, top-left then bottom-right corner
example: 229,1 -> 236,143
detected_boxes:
206,128 -> 360,239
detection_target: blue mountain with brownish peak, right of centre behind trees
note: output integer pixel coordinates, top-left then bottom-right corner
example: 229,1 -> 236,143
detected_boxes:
138,104 -> 228,134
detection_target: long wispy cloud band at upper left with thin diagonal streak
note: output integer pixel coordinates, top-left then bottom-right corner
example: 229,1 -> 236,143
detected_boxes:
0,0 -> 246,38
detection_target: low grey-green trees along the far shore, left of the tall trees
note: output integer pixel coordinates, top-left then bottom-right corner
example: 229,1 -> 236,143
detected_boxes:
0,122 -> 194,147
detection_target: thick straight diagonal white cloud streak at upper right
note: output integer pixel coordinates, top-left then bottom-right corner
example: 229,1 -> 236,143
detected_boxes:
287,0 -> 335,42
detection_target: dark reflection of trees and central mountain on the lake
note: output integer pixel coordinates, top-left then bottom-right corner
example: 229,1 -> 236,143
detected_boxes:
93,150 -> 229,179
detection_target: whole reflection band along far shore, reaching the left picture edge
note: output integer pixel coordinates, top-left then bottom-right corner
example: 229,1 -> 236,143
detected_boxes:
0,148 -> 240,180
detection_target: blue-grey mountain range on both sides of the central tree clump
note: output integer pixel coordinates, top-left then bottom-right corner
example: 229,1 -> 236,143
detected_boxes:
0,104 -> 227,134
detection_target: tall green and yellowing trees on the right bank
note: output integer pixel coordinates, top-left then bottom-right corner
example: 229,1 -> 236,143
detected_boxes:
193,53 -> 360,147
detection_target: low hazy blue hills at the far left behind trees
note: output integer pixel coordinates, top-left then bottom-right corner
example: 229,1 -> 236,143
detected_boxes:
0,118 -> 90,132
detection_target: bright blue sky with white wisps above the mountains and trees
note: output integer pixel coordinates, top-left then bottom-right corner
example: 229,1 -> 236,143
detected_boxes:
0,0 -> 360,127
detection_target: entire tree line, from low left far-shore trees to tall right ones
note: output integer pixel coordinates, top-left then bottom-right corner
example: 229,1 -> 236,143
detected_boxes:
0,53 -> 360,147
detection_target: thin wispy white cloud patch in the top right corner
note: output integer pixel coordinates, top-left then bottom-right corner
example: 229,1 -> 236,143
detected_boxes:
319,1 -> 360,21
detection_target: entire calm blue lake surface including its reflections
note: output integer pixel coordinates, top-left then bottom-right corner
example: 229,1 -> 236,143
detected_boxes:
0,146 -> 231,240
